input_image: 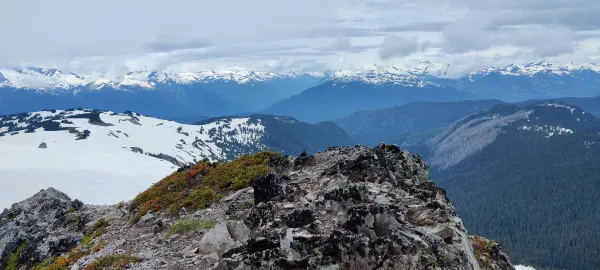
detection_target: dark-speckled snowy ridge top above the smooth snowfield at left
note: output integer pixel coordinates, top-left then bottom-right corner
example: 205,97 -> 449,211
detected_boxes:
0,109 -> 265,166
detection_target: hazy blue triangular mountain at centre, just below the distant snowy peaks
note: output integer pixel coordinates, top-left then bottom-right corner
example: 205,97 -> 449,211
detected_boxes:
265,77 -> 469,123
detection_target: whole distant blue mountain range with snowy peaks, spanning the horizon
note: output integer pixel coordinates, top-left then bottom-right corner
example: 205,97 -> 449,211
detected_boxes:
0,62 -> 600,122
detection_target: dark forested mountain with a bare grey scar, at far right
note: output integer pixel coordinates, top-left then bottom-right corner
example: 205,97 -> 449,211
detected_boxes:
426,102 -> 600,269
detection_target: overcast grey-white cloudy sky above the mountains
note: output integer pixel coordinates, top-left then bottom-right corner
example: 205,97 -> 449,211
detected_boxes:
0,0 -> 600,73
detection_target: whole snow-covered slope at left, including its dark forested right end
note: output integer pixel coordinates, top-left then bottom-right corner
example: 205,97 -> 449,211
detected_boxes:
0,109 -> 350,208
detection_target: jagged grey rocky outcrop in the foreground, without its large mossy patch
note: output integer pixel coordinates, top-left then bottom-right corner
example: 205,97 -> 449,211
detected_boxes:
0,145 -> 514,270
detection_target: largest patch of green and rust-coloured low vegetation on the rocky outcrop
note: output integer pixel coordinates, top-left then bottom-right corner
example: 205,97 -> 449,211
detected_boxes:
129,152 -> 280,223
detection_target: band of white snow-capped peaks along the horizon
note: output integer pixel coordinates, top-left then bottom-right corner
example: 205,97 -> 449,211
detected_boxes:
0,61 -> 600,90
